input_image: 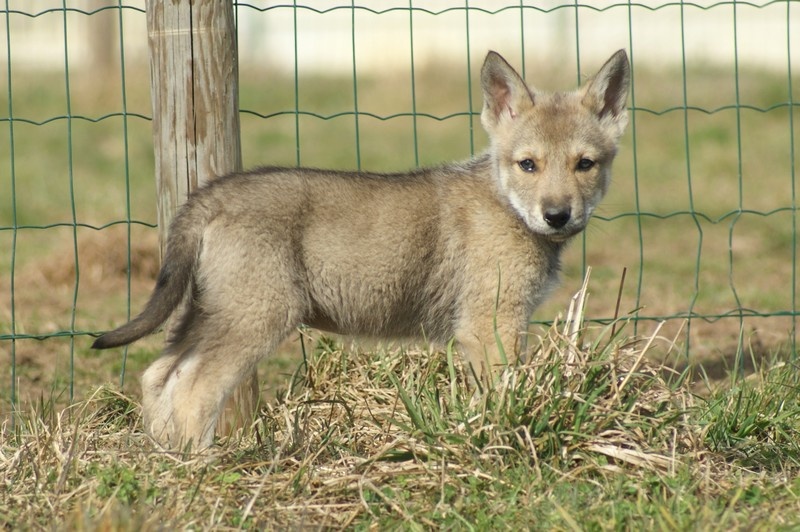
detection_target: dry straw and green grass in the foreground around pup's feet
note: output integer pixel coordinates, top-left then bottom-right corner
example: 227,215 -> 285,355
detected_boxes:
0,282 -> 800,530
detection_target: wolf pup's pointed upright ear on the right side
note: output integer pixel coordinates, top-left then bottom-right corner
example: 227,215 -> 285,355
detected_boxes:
581,50 -> 631,136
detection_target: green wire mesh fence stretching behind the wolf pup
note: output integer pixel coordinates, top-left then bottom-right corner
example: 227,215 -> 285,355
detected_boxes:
0,0 -> 800,414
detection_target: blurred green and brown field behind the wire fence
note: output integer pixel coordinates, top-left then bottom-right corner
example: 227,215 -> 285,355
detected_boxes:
0,54 -> 800,410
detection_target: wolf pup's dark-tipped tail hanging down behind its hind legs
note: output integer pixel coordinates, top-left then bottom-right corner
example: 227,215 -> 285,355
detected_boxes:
92,205 -> 206,349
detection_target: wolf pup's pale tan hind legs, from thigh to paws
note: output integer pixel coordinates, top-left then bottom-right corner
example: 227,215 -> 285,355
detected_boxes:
145,220 -> 310,449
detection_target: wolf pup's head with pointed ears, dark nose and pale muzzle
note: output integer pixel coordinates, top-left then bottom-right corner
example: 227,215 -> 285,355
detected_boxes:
481,50 -> 630,241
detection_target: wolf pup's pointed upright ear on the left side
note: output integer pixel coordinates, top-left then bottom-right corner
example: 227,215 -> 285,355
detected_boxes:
481,52 -> 533,134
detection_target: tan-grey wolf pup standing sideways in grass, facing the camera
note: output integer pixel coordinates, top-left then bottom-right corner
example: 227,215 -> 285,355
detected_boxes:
93,50 -> 630,448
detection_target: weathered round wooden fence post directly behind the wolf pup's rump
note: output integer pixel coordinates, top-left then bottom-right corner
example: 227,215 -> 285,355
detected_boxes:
146,0 -> 259,440
